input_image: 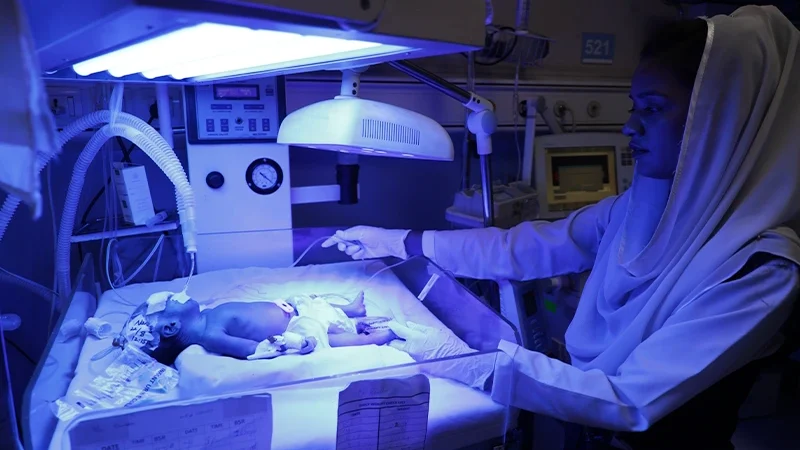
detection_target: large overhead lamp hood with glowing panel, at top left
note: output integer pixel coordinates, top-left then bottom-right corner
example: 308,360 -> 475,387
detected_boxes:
23,0 -> 486,83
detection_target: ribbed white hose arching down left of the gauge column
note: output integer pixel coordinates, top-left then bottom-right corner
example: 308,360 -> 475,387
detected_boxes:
56,123 -> 197,297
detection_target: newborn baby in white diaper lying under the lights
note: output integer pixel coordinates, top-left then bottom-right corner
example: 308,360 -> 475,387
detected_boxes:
114,292 -> 397,365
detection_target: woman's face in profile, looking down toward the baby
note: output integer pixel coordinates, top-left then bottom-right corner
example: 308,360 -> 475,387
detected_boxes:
622,60 -> 692,179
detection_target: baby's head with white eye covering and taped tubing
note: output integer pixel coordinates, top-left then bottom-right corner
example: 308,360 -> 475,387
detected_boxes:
114,292 -> 200,365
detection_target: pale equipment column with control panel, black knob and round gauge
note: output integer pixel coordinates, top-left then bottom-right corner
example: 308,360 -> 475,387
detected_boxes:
184,77 -> 294,272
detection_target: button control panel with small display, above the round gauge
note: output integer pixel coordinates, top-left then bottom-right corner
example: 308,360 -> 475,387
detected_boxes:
186,77 -> 285,144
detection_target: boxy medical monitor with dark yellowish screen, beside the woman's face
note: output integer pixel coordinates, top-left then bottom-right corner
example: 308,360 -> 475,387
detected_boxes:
535,133 -> 633,219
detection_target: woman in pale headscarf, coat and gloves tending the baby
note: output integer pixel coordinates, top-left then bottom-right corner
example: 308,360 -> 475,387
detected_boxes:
325,6 -> 800,449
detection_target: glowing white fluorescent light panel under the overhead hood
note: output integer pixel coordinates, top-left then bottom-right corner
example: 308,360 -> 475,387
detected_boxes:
72,23 -> 415,80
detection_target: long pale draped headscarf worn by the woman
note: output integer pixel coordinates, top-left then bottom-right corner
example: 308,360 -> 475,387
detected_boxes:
567,6 -> 800,374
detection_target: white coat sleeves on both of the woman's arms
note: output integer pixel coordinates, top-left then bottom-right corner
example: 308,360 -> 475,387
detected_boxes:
423,199 -> 800,431
